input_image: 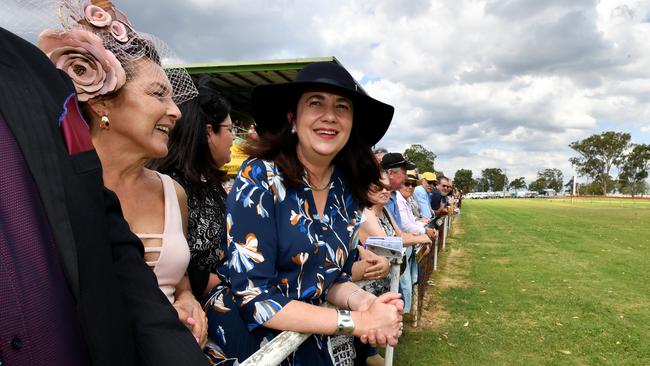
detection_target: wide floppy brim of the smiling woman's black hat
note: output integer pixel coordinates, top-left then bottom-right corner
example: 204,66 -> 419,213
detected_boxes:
251,82 -> 395,146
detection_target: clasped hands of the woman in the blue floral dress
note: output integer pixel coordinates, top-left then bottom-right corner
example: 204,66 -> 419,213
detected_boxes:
355,292 -> 404,346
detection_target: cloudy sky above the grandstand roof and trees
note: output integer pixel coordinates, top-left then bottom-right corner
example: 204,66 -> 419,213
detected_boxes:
7,0 -> 650,181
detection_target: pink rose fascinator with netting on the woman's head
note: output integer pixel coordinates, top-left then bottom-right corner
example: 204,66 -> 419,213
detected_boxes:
31,0 -> 198,104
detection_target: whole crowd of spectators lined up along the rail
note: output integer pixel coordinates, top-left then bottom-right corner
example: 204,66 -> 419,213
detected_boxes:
0,1 -> 453,366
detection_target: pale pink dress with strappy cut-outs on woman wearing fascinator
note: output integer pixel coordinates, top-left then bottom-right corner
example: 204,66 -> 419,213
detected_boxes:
136,172 -> 190,303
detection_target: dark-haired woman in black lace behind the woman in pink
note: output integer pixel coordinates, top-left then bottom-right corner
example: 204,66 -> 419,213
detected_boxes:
150,78 -> 235,298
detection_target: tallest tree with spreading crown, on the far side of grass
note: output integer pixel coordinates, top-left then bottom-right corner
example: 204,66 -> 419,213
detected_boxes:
569,131 -> 631,194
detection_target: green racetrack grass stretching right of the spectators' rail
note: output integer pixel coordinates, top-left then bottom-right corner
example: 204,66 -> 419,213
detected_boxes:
394,199 -> 650,366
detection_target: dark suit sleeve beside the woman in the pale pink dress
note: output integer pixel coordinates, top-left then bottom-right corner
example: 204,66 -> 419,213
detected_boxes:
105,189 -> 208,366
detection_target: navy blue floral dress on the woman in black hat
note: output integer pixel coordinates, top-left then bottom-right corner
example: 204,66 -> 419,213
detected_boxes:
226,159 -> 362,365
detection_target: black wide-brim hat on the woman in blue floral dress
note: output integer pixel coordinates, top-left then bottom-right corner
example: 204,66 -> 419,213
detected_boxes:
251,62 -> 395,146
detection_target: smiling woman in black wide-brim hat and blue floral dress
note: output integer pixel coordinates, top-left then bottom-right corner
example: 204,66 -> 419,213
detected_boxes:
226,62 -> 403,365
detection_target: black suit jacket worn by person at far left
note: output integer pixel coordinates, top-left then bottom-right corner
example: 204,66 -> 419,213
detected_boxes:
0,28 -> 208,366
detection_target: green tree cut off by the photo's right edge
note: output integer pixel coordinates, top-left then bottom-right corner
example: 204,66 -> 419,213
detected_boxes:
618,144 -> 650,197
